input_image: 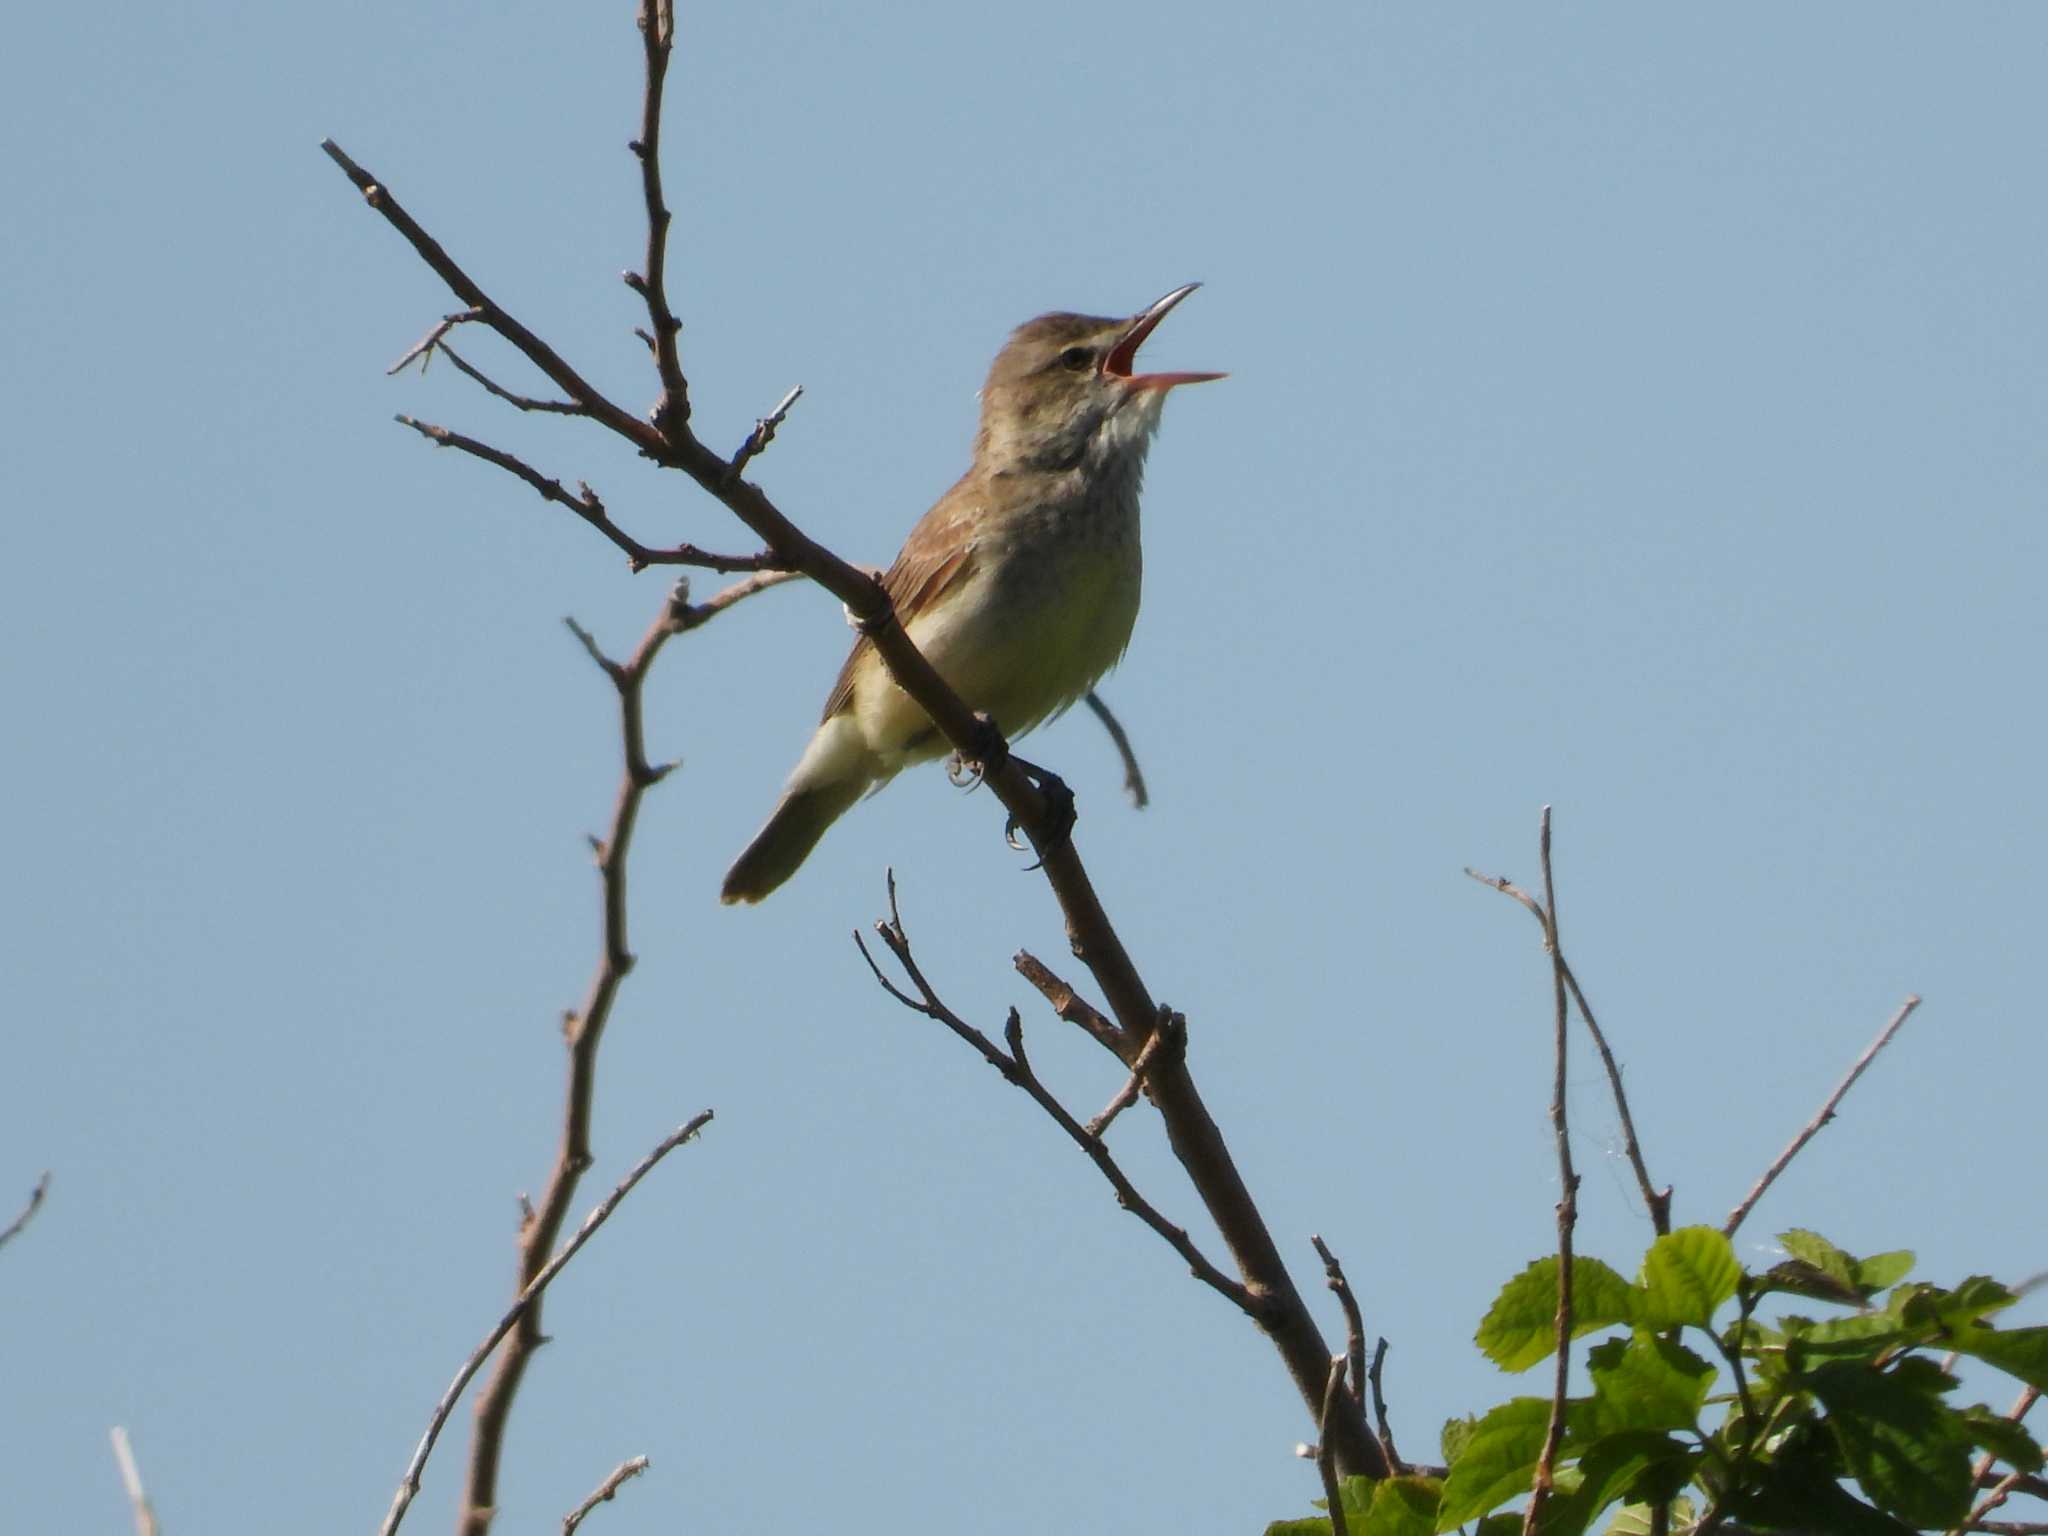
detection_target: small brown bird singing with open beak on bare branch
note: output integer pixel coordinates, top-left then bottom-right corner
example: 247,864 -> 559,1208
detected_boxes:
719,283 -> 1225,905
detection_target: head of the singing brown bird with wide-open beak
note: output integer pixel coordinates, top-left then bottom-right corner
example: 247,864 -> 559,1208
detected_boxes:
975,283 -> 1223,469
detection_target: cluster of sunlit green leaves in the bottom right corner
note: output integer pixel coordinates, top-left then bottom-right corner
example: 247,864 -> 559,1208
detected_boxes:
1268,1227 -> 2048,1536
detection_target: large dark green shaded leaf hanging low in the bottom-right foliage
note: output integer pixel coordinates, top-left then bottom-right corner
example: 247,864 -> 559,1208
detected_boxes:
1808,1360 -> 1970,1530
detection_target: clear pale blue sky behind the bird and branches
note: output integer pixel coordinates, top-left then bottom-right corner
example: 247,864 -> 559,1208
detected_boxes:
0,0 -> 2048,1532
